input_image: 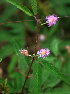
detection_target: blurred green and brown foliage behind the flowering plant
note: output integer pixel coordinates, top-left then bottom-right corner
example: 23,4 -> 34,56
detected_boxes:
0,0 -> 70,94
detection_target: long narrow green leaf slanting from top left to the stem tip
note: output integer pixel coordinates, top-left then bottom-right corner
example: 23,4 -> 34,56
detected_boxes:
6,0 -> 33,16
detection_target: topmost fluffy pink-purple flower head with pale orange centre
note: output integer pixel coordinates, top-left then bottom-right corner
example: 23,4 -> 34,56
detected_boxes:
46,14 -> 58,27
